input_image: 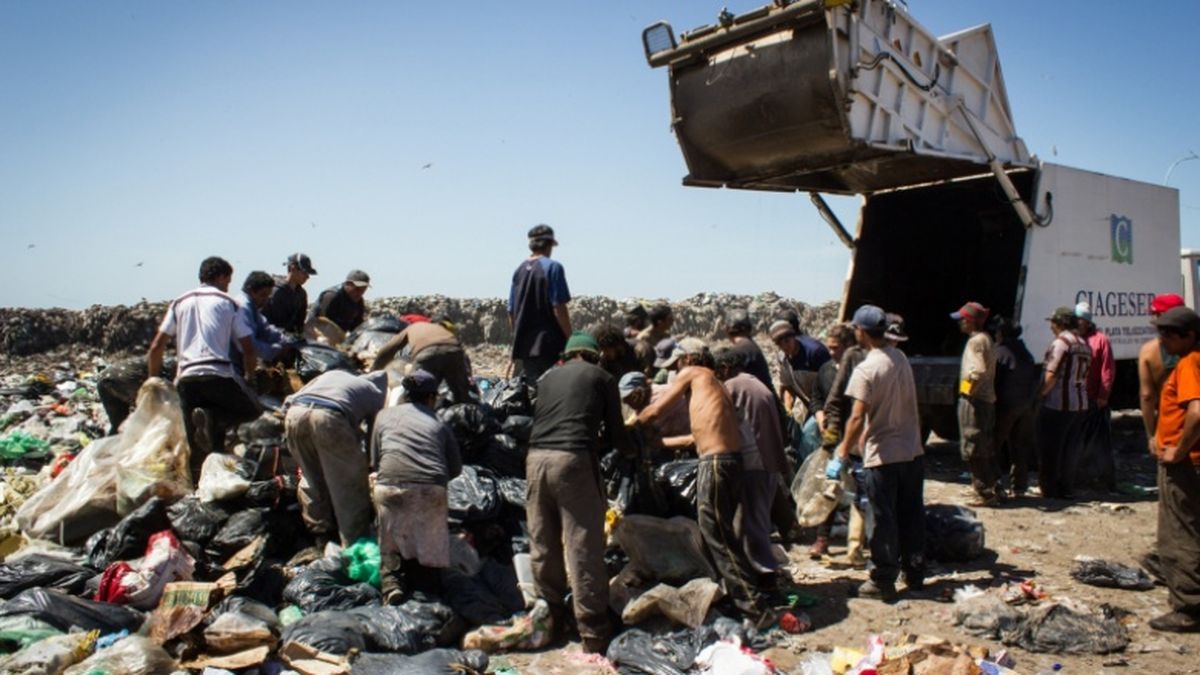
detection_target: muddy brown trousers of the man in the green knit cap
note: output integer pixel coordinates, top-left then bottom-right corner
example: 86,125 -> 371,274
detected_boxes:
526,448 -> 612,640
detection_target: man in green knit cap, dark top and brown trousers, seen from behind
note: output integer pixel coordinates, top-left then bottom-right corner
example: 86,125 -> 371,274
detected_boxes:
526,331 -> 634,653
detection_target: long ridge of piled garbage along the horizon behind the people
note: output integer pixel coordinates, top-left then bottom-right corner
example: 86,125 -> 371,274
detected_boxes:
0,288 -> 838,357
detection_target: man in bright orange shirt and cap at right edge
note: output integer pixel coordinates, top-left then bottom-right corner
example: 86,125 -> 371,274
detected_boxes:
1150,307 -> 1200,633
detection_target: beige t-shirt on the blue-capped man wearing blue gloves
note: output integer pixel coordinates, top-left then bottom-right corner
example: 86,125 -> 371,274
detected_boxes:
846,345 -> 925,467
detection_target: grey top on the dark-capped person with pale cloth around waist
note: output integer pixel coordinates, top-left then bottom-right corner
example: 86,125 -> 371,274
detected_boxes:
371,402 -> 462,488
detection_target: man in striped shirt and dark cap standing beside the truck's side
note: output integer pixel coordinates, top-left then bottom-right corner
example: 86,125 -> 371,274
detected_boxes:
1038,307 -> 1092,498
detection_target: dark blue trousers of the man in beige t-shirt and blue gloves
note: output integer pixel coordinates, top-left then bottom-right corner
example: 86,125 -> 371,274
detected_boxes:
863,458 -> 925,584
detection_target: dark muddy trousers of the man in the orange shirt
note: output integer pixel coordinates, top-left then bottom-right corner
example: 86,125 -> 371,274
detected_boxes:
1158,460 -> 1200,617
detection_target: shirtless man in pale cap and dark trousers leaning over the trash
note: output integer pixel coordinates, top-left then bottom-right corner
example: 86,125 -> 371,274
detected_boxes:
637,338 -> 774,627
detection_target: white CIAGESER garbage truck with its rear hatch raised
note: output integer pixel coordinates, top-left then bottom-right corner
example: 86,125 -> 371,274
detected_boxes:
642,0 -> 1180,438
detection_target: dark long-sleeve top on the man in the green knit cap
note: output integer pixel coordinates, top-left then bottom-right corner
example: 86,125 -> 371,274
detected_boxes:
529,359 -> 632,453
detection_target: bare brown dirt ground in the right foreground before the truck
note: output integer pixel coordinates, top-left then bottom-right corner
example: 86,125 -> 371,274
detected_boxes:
493,411 -> 1200,675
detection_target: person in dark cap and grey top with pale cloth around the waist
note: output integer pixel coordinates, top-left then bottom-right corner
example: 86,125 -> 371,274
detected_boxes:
371,368 -> 462,604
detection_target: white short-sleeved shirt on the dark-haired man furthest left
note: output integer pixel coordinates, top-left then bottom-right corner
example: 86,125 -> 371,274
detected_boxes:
158,285 -> 254,382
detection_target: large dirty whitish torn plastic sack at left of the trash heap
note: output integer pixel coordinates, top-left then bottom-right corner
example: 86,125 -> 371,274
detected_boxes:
17,377 -> 192,545
